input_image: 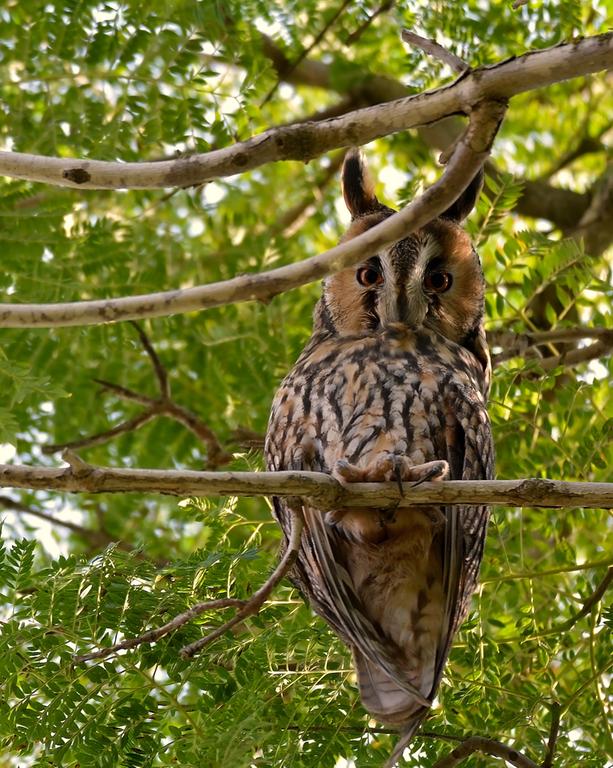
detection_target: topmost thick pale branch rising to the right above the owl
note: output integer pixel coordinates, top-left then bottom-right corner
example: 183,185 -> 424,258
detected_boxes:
0,33 -> 613,189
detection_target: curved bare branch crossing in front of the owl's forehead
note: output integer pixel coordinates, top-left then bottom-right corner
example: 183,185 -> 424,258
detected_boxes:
0,102 -> 505,328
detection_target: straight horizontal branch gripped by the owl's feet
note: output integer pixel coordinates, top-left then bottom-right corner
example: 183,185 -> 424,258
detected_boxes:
0,456 -> 613,509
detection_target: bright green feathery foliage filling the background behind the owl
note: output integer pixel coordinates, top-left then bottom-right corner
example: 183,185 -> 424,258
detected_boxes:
0,0 -> 613,768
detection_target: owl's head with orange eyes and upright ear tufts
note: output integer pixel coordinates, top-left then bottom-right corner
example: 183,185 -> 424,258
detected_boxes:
319,150 -> 487,367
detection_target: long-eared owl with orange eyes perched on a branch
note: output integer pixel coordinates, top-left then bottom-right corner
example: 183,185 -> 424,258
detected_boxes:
265,150 -> 493,736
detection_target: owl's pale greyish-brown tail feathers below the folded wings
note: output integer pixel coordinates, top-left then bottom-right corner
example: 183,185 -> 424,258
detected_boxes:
353,648 -> 428,735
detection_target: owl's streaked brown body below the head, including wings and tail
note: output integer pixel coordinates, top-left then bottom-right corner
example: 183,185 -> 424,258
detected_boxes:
266,326 -> 493,724
